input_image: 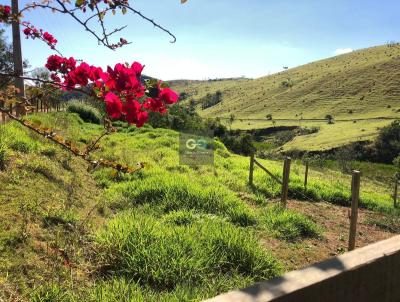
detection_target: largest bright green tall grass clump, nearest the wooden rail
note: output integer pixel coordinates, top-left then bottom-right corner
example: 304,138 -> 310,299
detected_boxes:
96,212 -> 281,290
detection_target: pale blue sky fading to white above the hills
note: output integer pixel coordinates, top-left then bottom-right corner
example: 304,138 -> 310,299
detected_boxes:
0,0 -> 400,80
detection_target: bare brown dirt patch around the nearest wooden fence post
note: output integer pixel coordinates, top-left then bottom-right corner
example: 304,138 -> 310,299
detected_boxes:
262,200 -> 395,270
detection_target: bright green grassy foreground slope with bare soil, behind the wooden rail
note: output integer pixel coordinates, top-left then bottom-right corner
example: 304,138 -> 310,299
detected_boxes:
0,113 -> 399,301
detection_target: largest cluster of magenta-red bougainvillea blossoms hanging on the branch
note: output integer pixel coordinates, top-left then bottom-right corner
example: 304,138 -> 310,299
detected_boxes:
46,55 -> 178,127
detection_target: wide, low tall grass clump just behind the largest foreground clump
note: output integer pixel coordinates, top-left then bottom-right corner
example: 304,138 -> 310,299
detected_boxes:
106,173 -> 256,226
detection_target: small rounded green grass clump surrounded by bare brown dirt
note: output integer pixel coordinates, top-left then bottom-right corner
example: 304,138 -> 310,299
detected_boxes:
261,205 -> 321,241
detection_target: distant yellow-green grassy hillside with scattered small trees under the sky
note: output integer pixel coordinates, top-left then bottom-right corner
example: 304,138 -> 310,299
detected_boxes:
174,46 -> 400,150
